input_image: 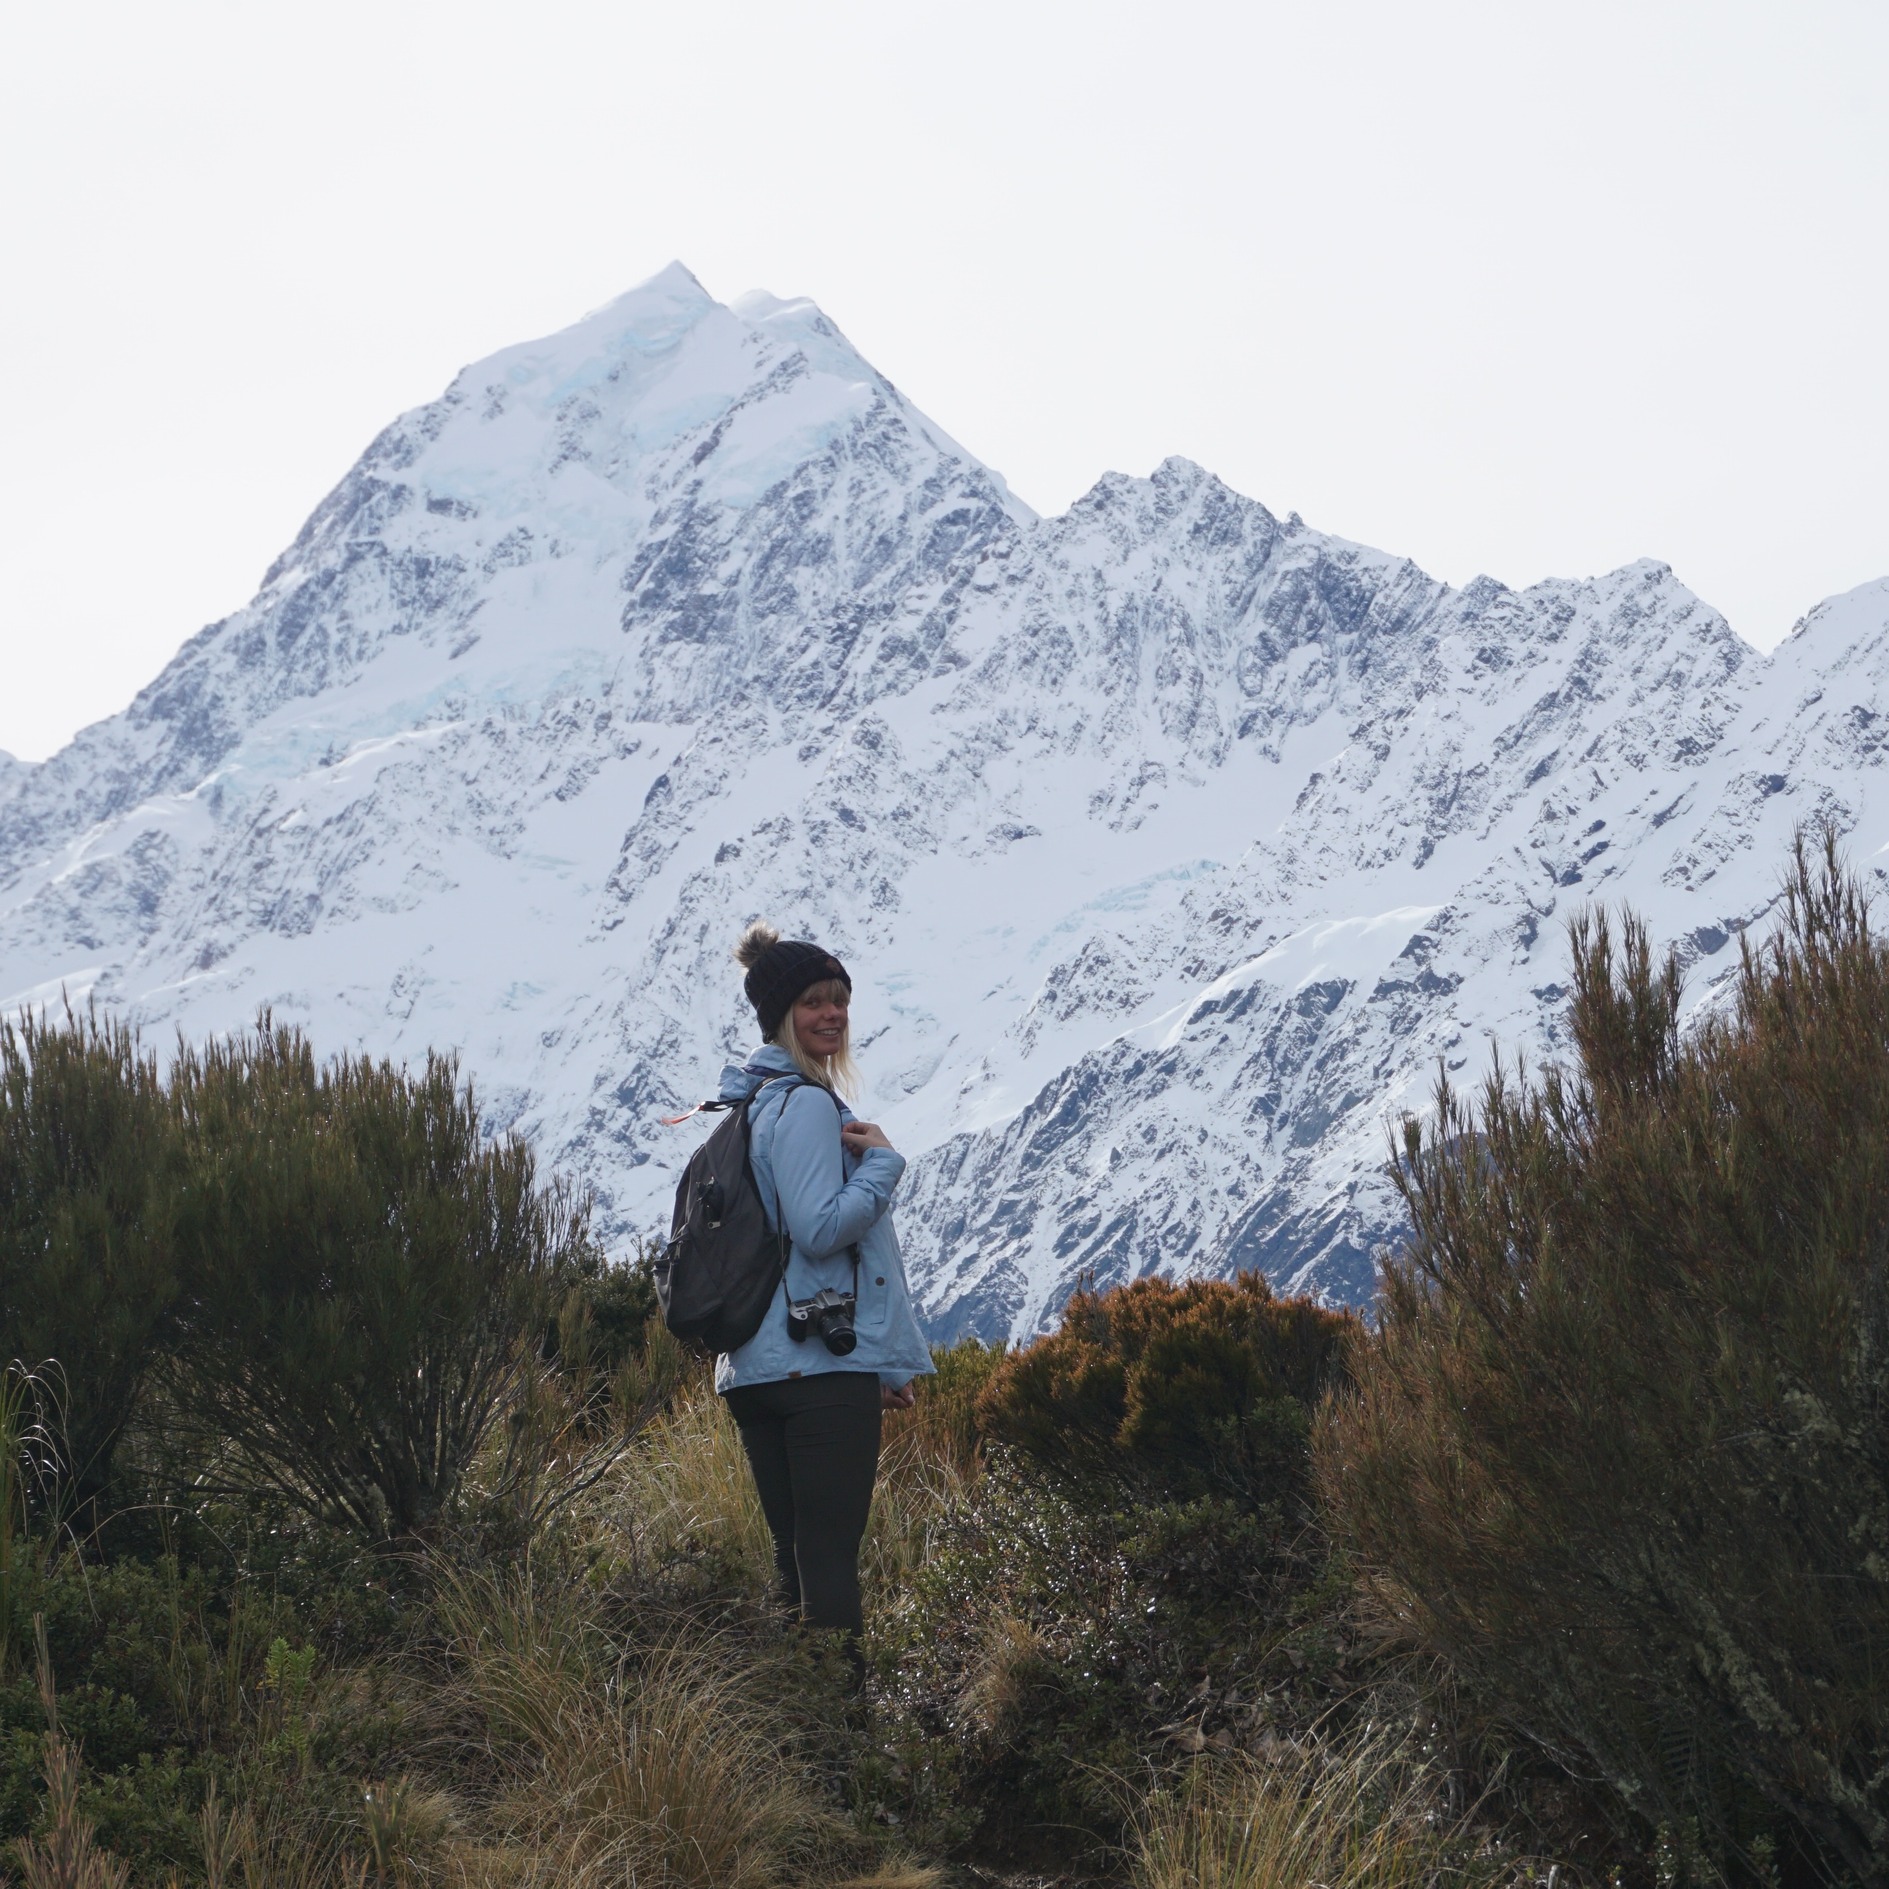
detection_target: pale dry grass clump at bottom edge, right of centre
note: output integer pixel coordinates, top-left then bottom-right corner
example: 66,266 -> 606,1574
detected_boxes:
1130,1727 -> 1519,1889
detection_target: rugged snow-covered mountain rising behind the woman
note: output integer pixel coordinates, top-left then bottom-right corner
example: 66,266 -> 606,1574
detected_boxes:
0,266 -> 1889,1334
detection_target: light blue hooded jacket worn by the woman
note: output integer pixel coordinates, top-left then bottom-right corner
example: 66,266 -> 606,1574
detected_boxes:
714,1043 -> 931,1390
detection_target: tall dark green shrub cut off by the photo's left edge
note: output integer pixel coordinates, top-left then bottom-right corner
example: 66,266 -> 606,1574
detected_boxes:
0,1009 -> 176,1524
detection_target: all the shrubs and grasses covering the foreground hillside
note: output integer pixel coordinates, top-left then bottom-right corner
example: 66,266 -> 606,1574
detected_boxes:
0,834 -> 1889,1889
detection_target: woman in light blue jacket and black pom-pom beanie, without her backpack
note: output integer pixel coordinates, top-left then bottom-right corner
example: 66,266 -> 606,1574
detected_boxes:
714,924 -> 931,1659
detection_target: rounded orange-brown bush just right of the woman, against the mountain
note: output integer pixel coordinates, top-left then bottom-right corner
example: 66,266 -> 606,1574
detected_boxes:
977,1273 -> 1356,1506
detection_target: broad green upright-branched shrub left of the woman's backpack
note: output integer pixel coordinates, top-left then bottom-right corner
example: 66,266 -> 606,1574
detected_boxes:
172,1018 -> 589,1536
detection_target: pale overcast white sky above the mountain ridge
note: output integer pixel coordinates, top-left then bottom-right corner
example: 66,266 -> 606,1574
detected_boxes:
0,0 -> 1889,759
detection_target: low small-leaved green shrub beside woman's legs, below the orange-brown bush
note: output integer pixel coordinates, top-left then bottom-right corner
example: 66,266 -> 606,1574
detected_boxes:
869,1445 -> 1343,1868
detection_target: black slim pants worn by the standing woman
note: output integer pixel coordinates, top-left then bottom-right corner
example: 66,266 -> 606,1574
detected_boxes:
727,1371 -> 878,1638
